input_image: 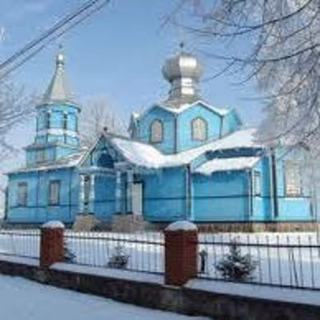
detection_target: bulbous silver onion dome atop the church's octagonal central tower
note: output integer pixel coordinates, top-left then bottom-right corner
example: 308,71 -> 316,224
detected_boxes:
162,47 -> 202,108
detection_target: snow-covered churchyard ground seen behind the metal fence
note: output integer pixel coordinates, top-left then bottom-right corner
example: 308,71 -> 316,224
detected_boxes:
0,231 -> 320,289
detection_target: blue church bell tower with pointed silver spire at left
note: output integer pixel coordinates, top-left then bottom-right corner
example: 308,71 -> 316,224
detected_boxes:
26,51 -> 81,166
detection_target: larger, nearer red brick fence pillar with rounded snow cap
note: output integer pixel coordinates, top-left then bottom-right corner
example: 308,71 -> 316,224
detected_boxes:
164,221 -> 198,286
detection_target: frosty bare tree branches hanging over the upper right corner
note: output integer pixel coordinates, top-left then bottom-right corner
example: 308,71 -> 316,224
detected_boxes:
172,0 -> 320,154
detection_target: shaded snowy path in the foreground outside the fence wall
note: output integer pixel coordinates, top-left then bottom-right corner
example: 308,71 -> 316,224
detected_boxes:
0,275 -> 206,320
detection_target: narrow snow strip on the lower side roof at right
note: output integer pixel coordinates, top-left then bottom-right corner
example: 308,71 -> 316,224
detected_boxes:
194,157 -> 261,175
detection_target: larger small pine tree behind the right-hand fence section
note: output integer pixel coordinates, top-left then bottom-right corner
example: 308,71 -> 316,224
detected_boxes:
215,240 -> 257,281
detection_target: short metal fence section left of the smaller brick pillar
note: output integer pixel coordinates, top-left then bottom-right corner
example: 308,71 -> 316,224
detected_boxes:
0,230 -> 40,258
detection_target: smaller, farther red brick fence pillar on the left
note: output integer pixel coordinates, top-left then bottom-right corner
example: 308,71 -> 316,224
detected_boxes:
40,221 -> 64,268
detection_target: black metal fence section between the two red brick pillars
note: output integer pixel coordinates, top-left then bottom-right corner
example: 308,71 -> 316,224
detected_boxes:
65,231 -> 164,273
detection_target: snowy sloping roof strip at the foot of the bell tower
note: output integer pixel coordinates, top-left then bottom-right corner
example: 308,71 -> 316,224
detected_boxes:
7,149 -> 87,174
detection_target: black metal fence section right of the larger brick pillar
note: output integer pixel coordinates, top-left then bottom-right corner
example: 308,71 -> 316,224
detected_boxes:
198,234 -> 320,290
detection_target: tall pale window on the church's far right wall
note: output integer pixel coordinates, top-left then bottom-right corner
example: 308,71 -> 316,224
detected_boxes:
284,160 -> 302,198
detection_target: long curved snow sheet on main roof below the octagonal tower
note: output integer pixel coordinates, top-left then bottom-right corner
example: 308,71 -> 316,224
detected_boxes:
109,129 -> 262,169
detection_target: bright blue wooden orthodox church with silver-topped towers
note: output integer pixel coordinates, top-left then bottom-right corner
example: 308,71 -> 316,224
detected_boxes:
6,49 -> 315,228
